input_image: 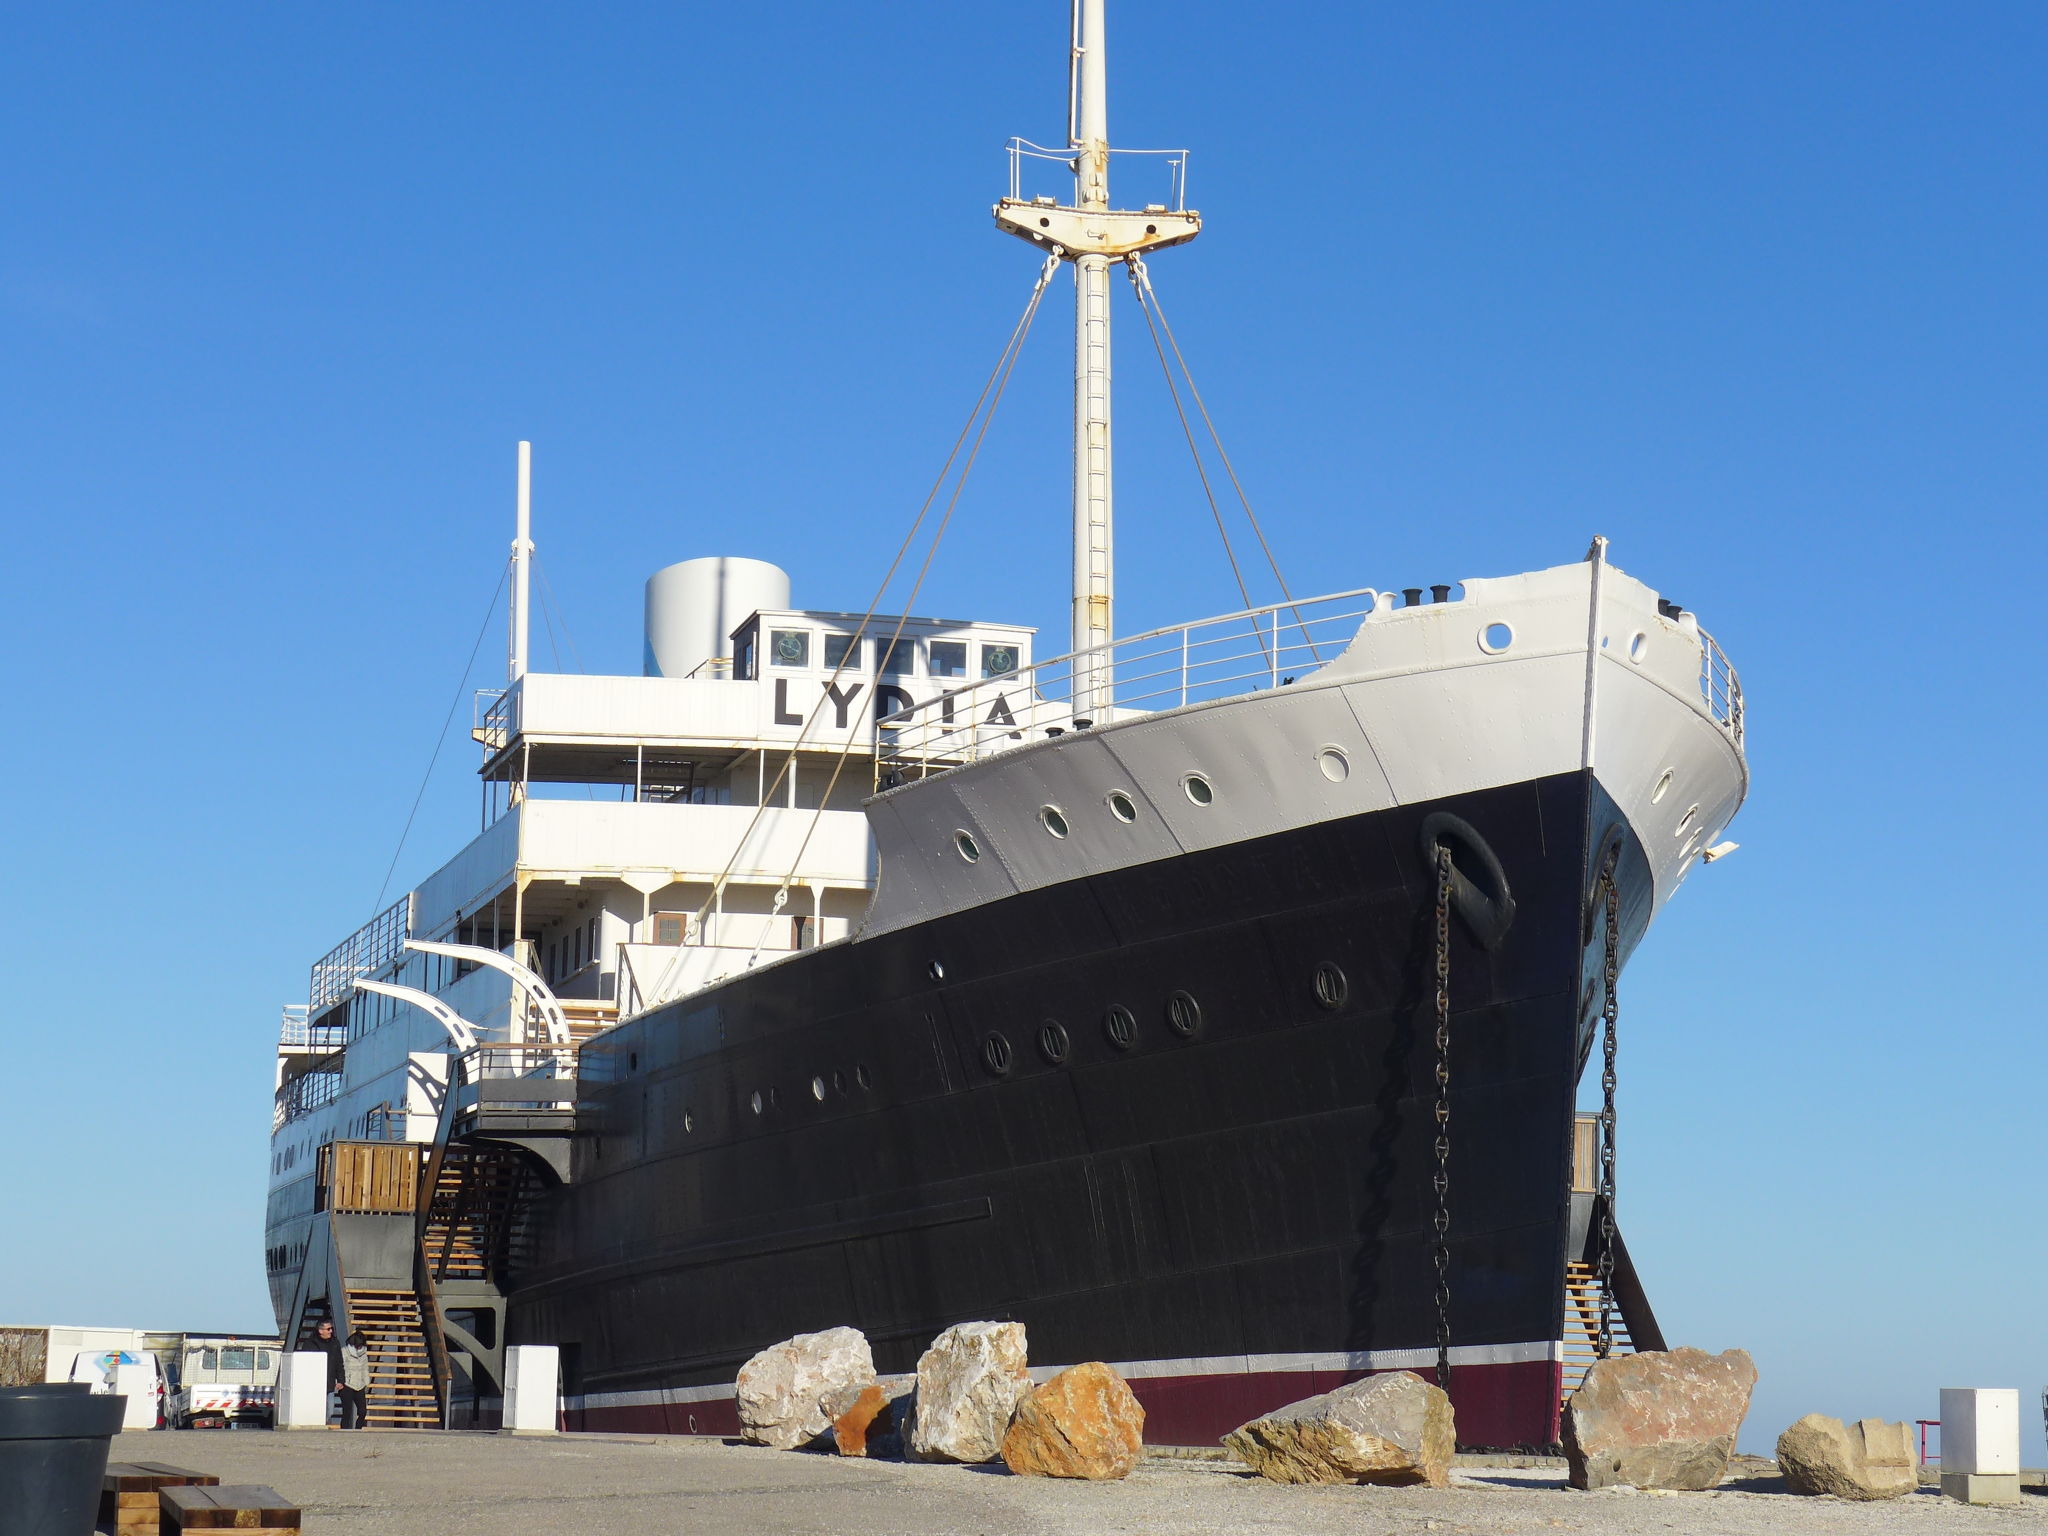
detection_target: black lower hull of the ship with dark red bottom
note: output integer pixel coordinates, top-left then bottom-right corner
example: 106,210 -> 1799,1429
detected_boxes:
508,772 -> 1651,1444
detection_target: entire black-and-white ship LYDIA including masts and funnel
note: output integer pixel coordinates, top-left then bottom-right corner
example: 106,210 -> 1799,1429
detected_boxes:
266,0 -> 1749,1448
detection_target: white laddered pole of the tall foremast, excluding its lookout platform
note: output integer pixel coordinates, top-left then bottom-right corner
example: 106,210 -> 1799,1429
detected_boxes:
1067,0 -> 1116,719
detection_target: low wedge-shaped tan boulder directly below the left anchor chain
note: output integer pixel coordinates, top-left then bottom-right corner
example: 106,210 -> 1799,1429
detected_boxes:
1223,1370 -> 1458,1489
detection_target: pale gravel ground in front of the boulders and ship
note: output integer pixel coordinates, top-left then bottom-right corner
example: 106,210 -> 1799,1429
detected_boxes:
113,1432 -> 2048,1536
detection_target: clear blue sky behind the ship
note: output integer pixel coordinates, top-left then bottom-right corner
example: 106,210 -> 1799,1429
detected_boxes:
0,0 -> 2048,1458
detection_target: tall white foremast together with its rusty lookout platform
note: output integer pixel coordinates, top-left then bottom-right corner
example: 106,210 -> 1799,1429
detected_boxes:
995,0 -> 1202,721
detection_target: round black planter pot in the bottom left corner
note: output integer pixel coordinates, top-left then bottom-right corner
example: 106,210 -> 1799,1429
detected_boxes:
0,1382 -> 127,1536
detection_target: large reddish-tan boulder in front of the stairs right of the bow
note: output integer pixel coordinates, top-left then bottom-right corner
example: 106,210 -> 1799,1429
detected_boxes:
1565,1350 -> 1757,1489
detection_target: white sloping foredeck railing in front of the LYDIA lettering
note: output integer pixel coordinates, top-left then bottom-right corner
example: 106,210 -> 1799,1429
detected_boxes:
874,588 -> 1382,788
